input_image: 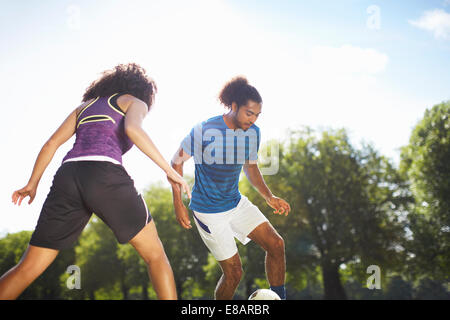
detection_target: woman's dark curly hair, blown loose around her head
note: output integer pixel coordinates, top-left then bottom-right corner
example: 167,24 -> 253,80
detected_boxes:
83,63 -> 158,109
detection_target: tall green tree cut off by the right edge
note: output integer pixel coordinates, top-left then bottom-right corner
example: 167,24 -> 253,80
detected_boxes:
400,102 -> 450,280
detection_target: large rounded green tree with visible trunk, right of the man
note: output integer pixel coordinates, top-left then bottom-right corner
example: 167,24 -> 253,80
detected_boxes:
243,129 -> 405,299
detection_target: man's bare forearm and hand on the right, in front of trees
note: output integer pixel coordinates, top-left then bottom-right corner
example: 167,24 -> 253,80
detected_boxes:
244,163 -> 291,215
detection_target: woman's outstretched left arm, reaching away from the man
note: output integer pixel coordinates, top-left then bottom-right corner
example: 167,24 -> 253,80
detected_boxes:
12,105 -> 80,206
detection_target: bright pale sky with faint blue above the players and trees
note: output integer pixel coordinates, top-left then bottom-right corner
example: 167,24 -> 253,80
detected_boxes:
0,0 -> 450,236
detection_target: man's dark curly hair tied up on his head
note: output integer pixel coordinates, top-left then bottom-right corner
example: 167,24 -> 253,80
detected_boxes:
219,76 -> 262,109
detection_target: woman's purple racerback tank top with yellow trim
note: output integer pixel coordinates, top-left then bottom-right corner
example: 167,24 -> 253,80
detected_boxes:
62,93 -> 133,164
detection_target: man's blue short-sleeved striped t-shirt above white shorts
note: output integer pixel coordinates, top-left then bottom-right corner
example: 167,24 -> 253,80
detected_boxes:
181,115 -> 261,213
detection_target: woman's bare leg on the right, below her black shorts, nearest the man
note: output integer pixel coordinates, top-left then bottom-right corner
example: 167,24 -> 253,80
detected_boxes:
130,220 -> 177,300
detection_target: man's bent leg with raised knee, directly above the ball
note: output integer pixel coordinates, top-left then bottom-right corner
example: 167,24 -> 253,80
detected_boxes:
248,222 -> 286,299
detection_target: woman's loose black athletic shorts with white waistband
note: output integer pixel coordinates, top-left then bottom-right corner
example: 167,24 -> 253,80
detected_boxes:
30,161 -> 152,250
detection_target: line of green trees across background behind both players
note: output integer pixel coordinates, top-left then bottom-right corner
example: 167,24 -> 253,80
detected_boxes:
0,102 -> 450,299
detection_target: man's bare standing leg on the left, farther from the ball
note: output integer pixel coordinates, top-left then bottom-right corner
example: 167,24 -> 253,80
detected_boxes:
214,253 -> 243,300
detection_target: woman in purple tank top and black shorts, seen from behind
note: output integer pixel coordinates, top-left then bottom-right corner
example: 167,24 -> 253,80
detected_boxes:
0,63 -> 190,299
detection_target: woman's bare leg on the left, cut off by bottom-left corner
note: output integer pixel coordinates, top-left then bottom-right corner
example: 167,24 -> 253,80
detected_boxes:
0,245 -> 59,300
